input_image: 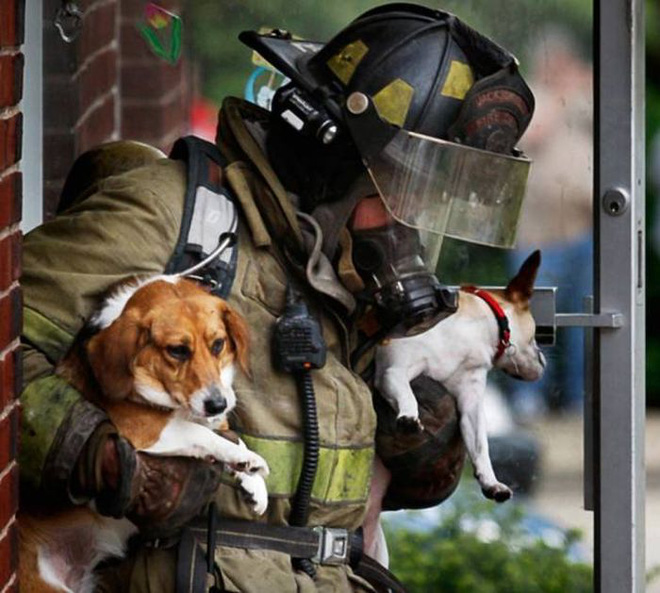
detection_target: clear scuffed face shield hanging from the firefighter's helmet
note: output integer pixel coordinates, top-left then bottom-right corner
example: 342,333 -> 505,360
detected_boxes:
365,130 -> 531,247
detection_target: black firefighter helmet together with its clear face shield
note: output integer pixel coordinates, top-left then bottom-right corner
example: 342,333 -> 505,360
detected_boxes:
239,3 -> 534,252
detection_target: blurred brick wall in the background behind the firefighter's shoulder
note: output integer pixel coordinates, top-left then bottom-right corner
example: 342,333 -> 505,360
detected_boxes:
44,0 -> 189,220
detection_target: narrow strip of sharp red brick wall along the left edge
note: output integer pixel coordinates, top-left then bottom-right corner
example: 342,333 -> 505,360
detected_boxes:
0,0 -> 25,593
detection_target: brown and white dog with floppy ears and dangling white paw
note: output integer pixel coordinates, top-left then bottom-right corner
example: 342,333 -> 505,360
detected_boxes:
19,276 -> 268,593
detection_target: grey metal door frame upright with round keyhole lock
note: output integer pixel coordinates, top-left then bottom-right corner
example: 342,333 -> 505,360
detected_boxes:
593,0 -> 646,593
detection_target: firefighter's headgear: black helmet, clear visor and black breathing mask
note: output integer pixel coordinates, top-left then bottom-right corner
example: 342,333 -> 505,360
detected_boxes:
240,4 -> 534,331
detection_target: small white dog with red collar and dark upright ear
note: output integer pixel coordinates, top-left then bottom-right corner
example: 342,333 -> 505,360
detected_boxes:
375,251 -> 545,502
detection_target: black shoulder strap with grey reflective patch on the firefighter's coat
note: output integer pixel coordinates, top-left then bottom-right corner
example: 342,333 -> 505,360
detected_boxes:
165,136 -> 238,298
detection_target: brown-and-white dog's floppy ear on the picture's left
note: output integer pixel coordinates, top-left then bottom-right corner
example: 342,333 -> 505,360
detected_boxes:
87,314 -> 148,401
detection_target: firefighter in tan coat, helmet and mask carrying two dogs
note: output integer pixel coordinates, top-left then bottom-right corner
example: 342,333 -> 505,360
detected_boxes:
20,4 -> 534,593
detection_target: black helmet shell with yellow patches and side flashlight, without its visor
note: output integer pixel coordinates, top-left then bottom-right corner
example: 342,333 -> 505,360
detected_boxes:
239,3 -> 534,162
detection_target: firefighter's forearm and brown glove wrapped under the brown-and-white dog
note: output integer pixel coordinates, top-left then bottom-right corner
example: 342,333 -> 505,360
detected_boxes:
20,345 -> 219,536
